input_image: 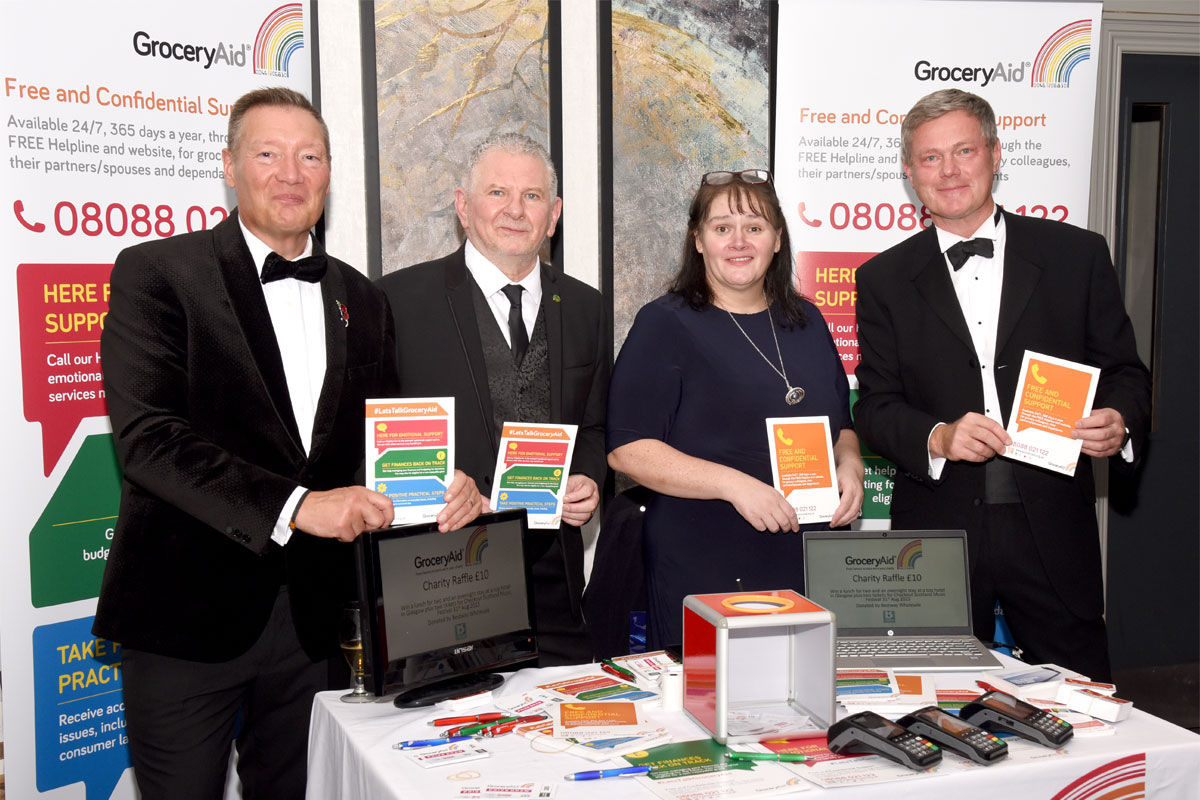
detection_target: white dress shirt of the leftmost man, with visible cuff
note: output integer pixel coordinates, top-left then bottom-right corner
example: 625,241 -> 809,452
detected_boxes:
239,219 -> 325,545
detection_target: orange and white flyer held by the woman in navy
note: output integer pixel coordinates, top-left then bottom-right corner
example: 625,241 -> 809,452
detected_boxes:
767,416 -> 839,525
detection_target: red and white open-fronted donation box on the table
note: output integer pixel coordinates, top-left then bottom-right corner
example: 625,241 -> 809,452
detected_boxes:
683,589 -> 838,745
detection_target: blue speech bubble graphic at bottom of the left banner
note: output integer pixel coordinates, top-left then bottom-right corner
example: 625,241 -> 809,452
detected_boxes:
34,616 -> 130,800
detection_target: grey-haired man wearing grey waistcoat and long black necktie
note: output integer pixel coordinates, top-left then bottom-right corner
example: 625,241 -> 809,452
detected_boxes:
379,133 -> 610,666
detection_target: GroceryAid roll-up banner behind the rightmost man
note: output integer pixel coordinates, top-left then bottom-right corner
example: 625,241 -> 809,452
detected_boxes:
774,0 -> 1102,527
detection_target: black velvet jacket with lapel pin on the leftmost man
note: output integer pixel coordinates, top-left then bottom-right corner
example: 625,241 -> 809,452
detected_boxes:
94,212 -> 395,662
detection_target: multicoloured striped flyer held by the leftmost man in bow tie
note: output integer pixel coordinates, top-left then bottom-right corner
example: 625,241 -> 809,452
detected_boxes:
366,397 -> 454,525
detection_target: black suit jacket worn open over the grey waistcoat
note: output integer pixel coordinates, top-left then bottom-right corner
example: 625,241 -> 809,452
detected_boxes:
379,245 -> 610,616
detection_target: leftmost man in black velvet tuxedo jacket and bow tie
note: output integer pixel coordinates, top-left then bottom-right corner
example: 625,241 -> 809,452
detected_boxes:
94,89 -> 481,800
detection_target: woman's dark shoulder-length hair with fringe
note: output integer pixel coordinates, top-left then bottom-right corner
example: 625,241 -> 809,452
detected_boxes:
667,180 -> 806,327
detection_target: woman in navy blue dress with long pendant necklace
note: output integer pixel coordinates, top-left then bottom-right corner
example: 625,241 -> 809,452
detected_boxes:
607,169 -> 863,648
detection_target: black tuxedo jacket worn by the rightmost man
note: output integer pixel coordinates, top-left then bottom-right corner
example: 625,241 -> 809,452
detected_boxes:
854,212 -> 1150,618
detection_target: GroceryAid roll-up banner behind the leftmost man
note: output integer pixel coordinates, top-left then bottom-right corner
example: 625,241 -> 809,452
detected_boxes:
0,0 -> 312,800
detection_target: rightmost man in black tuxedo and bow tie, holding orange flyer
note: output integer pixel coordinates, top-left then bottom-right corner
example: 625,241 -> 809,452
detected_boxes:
854,89 -> 1150,679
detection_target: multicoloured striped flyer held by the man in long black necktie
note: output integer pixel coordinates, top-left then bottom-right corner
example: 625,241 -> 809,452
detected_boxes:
491,422 -> 578,529
